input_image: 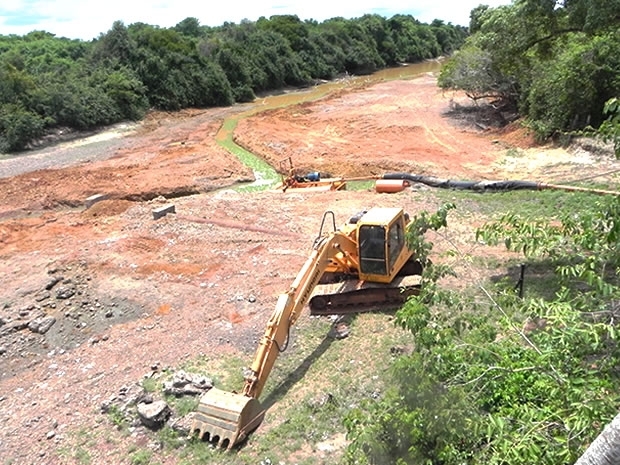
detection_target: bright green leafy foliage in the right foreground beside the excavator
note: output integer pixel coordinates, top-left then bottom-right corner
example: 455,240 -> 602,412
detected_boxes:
346,198 -> 620,465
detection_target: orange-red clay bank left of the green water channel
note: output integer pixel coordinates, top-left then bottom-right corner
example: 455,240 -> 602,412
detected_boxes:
0,109 -> 254,218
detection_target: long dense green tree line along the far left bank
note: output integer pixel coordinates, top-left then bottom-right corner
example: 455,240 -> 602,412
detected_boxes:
0,15 -> 466,151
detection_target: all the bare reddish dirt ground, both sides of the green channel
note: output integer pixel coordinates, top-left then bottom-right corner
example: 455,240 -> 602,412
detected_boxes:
0,76 -> 617,464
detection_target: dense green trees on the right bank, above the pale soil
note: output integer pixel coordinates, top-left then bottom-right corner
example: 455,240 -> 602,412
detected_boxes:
439,0 -> 620,138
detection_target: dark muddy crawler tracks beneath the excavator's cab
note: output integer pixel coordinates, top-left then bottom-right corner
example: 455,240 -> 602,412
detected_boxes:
308,275 -> 420,315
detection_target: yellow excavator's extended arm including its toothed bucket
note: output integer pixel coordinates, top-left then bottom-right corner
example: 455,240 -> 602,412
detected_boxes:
191,227 -> 359,449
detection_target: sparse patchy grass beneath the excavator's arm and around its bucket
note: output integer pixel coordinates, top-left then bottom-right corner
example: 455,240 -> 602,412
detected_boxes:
144,313 -> 412,465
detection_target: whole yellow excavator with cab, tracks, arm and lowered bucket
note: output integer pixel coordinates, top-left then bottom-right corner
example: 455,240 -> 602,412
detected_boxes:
191,208 -> 422,449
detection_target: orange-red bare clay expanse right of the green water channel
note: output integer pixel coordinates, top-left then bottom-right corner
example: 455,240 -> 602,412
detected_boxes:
235,76 -> 528,178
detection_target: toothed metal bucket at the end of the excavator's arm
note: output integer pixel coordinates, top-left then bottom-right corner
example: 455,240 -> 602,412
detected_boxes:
190,388 -> 265,450
